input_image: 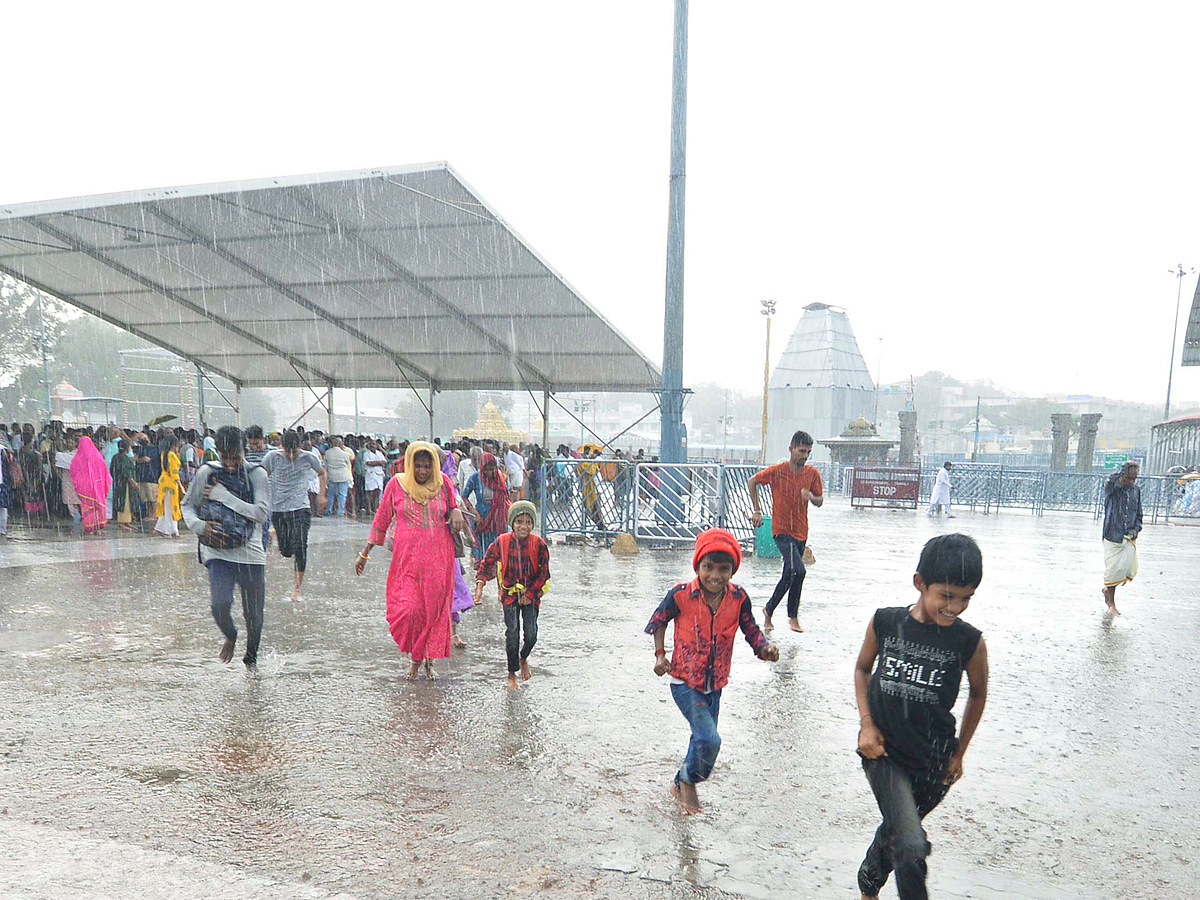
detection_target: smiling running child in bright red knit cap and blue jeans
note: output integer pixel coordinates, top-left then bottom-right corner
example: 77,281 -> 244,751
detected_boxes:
646,528 -> 779,815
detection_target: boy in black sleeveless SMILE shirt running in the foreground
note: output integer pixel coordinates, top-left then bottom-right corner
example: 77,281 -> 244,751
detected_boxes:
854,534 -> 988,900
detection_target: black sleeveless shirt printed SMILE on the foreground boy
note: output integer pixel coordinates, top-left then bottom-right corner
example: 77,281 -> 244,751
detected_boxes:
866,606 -> 983,775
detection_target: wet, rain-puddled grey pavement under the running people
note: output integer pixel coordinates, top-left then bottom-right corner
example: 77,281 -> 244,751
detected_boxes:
0,508 -> 1200,900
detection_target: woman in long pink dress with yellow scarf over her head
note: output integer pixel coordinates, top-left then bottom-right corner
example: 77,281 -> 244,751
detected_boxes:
354,440 -> 469,682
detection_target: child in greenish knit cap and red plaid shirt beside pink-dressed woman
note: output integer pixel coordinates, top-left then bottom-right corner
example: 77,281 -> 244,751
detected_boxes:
475,500 -> 550,690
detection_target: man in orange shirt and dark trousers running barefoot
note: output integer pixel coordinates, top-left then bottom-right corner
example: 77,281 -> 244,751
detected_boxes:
749,431 -> 824,631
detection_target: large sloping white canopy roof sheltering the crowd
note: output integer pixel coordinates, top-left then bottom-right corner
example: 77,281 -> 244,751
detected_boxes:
0,163 -> 660,441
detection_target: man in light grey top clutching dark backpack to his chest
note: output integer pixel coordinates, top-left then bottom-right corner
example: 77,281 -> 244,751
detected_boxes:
182,425 -> 269,670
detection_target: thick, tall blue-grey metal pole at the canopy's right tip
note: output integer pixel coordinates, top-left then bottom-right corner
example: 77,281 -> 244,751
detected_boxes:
659,0 -> 688,463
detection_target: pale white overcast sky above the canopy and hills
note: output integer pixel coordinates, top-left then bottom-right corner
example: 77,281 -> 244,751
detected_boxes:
0,0 -> 1200,406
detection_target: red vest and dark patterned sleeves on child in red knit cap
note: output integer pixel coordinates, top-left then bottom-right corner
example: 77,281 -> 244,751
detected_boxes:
646,578 -> 768,691
